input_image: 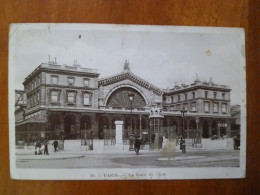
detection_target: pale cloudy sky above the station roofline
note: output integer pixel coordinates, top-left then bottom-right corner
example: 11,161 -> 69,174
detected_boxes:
10,24 -> 245,104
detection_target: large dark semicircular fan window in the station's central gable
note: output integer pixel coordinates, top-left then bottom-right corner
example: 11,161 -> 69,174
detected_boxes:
107,87 -> 146,109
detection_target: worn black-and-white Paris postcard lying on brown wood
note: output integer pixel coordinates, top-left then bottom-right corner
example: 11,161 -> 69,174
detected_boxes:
9,24 -> 246,180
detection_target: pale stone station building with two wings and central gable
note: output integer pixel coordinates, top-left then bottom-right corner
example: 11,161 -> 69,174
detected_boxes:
15,62 -> 234,144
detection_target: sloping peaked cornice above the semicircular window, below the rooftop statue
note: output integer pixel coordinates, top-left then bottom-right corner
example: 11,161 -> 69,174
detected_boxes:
98,71 -> 163,95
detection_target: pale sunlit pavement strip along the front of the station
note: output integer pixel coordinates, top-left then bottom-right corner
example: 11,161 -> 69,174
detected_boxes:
16,139 -> 233,161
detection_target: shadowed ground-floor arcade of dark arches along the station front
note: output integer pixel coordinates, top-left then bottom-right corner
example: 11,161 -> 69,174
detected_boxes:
16,111 -> 233,145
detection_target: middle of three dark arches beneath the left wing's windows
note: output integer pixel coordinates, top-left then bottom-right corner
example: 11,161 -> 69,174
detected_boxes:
64,114 -> 76,139
